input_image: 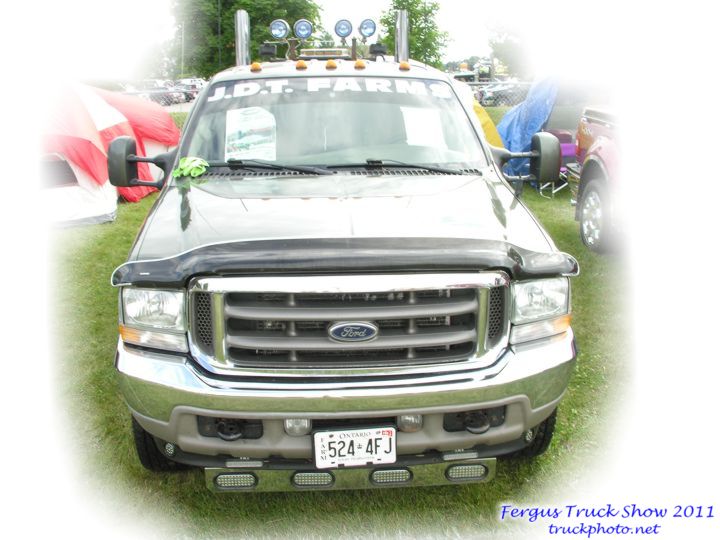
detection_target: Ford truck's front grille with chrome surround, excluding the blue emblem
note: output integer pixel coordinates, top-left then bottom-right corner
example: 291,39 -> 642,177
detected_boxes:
191,278 -> 506,369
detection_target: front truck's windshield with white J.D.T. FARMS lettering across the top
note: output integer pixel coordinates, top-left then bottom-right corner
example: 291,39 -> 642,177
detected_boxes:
181,77 -> 487,168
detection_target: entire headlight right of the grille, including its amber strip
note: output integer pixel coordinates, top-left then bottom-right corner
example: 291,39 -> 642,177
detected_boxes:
510,278 -> 570,343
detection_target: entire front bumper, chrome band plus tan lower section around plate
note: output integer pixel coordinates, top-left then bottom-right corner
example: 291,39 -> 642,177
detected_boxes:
116,330 -> 575,460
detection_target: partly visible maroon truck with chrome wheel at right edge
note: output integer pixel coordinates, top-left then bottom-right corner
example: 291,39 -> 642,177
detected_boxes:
567,107 -> 621,253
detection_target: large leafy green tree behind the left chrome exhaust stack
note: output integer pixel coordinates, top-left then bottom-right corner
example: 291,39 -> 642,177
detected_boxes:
172,0 -> 322,77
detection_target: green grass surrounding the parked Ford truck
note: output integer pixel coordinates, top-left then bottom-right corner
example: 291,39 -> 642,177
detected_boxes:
53,113 -> 629,538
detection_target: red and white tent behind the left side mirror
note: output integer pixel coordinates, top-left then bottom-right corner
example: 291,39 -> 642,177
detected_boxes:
42,84 -> 180,223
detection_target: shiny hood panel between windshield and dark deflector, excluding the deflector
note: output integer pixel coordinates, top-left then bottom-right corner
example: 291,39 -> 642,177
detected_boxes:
130,168 -> 554,260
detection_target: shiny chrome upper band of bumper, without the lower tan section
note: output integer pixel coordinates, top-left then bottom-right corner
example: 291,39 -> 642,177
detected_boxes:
116,330 -> 575,422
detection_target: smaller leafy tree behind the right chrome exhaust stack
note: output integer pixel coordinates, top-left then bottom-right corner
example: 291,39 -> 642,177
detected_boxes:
379,0 -> 448,69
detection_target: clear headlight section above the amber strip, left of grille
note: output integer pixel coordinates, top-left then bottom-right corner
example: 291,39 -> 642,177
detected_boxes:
123,287 -> 185,332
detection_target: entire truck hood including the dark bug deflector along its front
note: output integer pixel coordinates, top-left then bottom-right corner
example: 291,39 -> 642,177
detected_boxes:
112,169 -> 579,288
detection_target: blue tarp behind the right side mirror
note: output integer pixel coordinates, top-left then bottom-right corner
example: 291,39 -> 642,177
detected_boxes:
497,79 -> 558,175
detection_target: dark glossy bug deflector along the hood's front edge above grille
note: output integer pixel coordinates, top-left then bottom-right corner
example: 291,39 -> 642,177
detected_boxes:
111,238 -> 579,288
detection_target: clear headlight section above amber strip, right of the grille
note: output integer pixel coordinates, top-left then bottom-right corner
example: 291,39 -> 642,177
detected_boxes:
511,278 -> 570,324
